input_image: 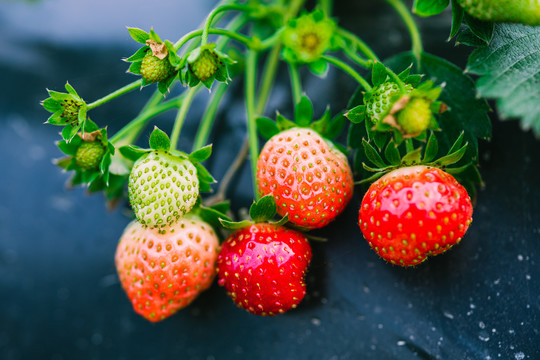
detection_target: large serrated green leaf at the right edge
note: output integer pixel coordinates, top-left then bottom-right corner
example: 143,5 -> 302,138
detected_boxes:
467,24 -> 540,137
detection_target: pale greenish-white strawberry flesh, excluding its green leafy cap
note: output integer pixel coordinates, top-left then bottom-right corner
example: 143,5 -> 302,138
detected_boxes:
128,150 -> 199,228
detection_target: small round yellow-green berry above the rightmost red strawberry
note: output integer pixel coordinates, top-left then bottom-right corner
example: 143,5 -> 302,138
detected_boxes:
397,98 -> 433,136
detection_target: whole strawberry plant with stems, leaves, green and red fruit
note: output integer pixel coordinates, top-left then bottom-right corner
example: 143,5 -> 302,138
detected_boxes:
42,0 -> 540,321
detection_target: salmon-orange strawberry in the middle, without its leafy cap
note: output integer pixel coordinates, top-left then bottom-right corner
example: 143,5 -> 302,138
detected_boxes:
257,128 -> 354,229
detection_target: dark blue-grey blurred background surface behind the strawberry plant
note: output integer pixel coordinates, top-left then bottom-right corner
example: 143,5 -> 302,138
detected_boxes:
0,0 -> 540,360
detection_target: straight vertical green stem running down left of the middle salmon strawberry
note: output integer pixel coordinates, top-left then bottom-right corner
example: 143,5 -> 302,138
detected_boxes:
245,50 -> 259,199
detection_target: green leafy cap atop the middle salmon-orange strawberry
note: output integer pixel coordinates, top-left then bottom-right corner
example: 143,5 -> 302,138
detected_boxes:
257,94 -> 346,153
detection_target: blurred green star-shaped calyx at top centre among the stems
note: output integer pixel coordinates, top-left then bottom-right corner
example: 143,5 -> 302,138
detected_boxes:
281,9 -> 336,63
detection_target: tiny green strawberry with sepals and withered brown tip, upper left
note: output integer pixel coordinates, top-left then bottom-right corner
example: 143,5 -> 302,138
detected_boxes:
125,28 -> 182,94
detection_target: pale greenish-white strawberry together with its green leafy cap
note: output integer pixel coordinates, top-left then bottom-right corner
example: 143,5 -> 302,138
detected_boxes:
119,128 -> 215,228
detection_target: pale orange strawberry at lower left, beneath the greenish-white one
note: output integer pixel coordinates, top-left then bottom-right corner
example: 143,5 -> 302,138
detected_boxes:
115,215 -> 219,322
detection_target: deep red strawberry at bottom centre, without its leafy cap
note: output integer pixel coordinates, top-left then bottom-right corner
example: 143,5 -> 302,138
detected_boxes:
218,223 -> 311,316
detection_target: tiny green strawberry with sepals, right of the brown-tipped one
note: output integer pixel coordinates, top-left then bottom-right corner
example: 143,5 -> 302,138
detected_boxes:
182,44 -> 234,89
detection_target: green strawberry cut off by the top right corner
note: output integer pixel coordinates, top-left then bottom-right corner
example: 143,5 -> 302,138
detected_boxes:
458,0 -> 540,25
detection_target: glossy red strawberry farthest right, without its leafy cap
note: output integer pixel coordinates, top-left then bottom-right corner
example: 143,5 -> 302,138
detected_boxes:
359,165 -> 473,266
